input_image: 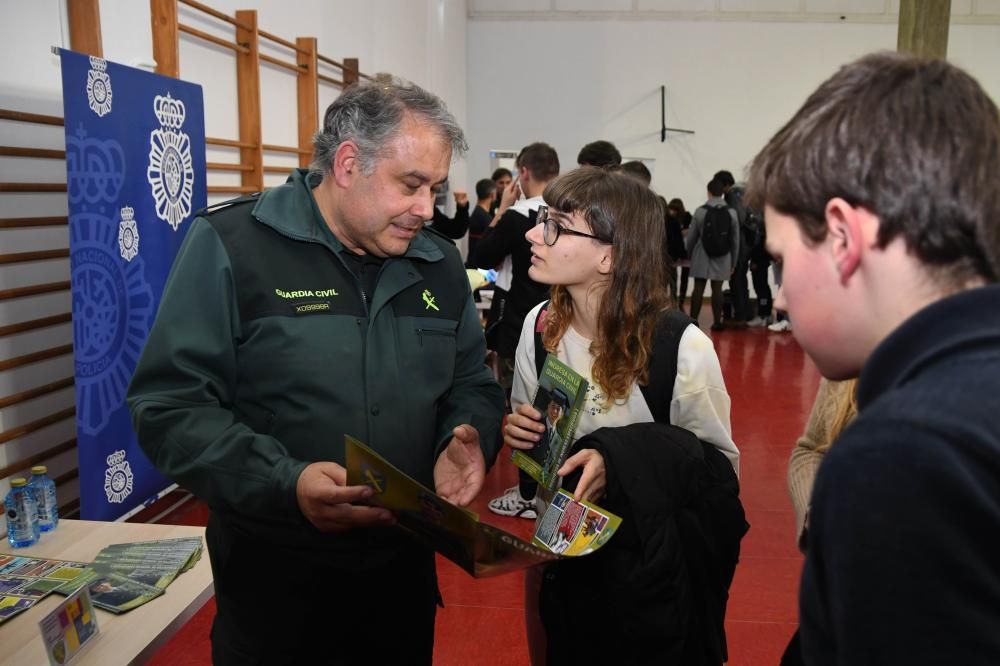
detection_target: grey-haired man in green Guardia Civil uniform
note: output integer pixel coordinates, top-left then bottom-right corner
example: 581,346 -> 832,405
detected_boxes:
128,76 -> 504,664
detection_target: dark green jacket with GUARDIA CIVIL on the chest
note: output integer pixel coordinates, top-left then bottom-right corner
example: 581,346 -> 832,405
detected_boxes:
127,170 -> 504,550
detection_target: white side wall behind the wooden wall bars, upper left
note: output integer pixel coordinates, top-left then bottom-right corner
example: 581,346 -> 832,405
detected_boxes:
90,0 -> 466,199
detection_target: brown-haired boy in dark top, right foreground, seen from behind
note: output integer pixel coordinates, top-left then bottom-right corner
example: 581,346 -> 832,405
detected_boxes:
747,53 -> 1000,666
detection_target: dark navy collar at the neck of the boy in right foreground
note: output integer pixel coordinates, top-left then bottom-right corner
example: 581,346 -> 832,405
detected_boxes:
858,284 -> 1000,410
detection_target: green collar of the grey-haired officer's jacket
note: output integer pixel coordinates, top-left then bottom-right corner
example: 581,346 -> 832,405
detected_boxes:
253,169 -> 444,261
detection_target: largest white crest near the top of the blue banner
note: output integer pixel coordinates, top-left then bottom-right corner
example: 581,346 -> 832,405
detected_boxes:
146,93 -> 194,231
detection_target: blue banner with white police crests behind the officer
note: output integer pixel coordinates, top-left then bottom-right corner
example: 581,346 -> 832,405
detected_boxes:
60,50 -> 206,520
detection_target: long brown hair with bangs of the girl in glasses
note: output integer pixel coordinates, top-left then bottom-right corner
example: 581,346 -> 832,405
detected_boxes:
542,167 -> 670,405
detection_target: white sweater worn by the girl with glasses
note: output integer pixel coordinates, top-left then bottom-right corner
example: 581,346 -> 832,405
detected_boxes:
510,304 -> 740,476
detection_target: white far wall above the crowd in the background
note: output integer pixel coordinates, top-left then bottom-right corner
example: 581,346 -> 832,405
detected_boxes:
468,16 -> 1000,209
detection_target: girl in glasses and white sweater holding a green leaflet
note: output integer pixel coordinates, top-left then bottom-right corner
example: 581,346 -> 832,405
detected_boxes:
504,167 -> 739,663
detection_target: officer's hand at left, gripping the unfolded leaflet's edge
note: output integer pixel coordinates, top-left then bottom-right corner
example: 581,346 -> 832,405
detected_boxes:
295,462 -> 395,532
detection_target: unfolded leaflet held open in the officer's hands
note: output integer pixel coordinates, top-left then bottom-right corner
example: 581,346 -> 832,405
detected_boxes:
344,436 -> 621,578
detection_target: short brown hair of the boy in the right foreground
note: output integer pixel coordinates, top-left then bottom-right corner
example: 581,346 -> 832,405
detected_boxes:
747,53 -> 1000,287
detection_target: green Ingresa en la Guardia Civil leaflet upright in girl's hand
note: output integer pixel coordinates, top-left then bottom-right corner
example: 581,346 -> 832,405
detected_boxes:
513,354 -> 587,491
